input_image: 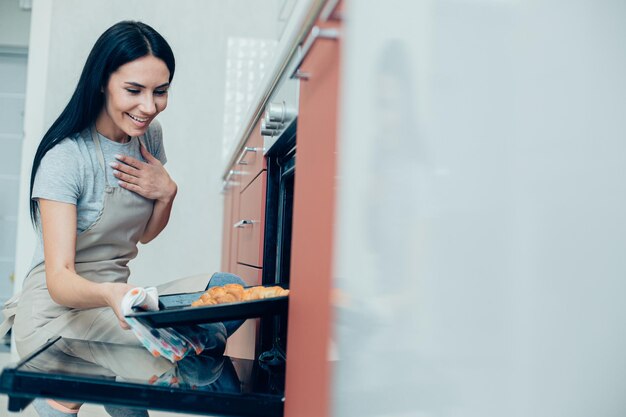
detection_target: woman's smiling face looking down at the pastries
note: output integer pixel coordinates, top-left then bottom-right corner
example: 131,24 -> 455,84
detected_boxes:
96,55 -> 170,142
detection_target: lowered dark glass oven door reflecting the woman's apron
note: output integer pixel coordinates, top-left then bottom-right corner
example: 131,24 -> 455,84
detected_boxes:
0,337 -> 284,417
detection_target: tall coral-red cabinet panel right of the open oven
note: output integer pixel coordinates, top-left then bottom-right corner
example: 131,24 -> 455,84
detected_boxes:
285,6 -> 341,417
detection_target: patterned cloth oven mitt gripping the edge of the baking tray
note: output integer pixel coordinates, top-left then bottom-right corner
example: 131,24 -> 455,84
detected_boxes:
122,287 -> 210,362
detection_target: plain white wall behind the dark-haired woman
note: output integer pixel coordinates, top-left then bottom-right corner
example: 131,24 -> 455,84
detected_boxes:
15,0 -> 277,288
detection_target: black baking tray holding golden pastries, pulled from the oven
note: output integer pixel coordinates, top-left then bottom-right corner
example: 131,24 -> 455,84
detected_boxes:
127,291 -> 289,328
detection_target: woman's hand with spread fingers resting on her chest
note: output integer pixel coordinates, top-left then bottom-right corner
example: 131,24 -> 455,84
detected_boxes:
110,144 -> 177,203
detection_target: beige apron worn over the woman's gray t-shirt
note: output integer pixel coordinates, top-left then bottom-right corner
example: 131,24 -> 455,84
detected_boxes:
11,128 -> 154,357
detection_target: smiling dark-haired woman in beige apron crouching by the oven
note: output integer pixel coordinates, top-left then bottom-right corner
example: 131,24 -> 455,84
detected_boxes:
2,21 -> 241,416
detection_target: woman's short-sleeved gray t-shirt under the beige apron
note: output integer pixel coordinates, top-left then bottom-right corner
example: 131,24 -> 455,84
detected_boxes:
31,120 -> 167,268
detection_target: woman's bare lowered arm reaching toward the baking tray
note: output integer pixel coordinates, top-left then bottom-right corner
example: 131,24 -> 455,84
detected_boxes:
39,199 -> 133,328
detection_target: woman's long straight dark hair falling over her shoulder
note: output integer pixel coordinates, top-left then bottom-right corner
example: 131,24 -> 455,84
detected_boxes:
30,21 -> 175,226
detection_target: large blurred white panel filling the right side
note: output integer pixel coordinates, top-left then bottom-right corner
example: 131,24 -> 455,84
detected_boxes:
333,0 -> 626,417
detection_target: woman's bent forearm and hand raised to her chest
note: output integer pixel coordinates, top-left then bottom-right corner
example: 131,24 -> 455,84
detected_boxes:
112,144 -> 178,243
